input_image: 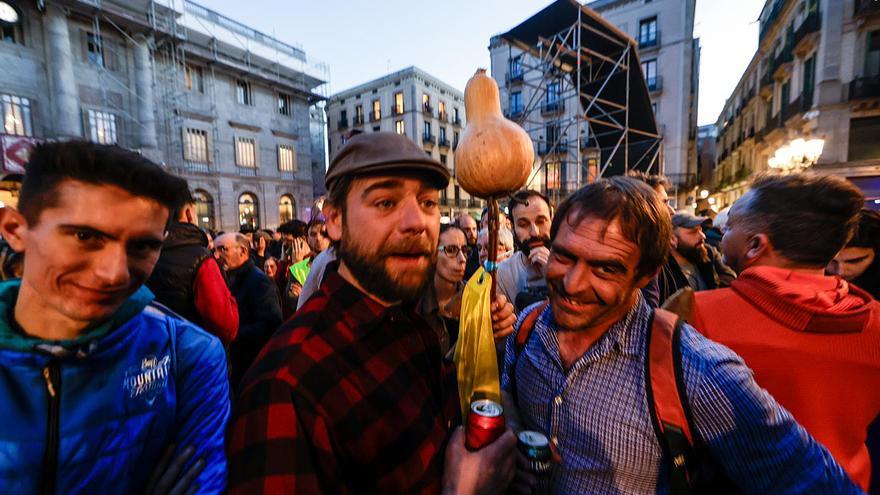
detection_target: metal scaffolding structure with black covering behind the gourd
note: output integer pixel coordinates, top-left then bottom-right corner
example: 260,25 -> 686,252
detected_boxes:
500,0 -> 663,201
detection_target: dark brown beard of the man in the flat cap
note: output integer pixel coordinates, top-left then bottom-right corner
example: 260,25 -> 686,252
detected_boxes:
337,228 -> 437,302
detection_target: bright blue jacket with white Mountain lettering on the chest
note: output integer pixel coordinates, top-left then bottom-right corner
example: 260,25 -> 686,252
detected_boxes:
0,280 -> 230,494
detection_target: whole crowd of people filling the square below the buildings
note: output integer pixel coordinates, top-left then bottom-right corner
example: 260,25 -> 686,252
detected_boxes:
0,133 -> 880,495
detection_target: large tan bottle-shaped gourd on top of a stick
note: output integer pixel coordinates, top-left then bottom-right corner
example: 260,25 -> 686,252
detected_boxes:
455,69 -> 535,199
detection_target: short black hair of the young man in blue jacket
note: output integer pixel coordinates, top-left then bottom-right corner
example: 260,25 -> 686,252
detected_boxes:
18,140 -> 191,225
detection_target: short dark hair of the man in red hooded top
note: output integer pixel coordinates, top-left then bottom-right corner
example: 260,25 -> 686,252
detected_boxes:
740,173 -> 865,267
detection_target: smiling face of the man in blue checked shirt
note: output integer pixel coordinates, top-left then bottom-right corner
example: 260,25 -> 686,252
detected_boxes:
547,217 -> 651,332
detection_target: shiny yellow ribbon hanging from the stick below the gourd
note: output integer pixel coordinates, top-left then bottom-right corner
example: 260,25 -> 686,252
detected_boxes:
454,268 -> 501,421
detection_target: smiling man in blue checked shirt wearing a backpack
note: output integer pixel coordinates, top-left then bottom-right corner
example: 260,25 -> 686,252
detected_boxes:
501,176 -> 860,495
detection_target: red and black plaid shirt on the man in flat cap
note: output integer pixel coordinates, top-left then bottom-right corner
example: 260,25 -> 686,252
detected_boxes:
229,269 -> 458,494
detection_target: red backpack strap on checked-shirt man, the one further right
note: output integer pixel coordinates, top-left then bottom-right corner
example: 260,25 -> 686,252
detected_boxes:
645,309 -> 695,495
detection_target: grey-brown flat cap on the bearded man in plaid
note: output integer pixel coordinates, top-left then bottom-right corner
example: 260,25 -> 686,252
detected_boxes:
324,132 -> 449,191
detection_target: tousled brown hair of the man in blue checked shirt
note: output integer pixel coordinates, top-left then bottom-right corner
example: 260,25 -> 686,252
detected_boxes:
550,176 -> 672,277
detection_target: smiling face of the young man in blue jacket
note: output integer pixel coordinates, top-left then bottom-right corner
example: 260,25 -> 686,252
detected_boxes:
3,180 -> 169,329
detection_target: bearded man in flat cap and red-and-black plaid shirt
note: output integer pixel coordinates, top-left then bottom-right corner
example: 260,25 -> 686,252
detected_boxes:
229,133 -> 515,494
